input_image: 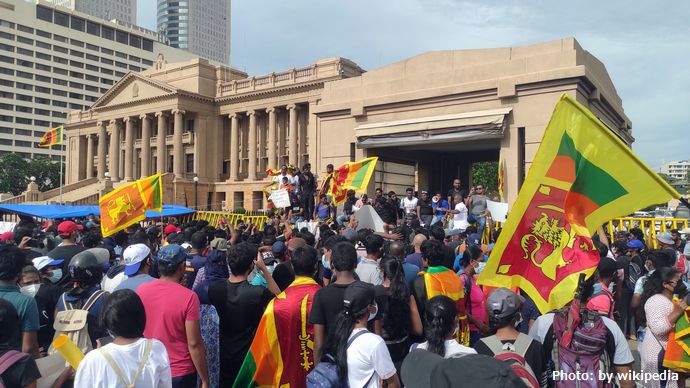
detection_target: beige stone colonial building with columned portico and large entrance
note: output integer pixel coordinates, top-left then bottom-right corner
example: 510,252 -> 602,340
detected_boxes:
61,38 -> 634,209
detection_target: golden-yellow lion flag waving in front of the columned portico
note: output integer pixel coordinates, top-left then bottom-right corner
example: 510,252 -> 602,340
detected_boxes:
98,174 -> 163,237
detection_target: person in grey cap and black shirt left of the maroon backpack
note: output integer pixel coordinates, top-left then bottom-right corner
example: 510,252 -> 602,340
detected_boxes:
474,288 -> 547,387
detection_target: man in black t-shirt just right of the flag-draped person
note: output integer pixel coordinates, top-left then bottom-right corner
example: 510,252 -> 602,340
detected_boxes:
309,242 -> 357,364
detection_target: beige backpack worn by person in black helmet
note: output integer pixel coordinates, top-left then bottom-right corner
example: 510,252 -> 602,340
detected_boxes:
48,290 -> 106,354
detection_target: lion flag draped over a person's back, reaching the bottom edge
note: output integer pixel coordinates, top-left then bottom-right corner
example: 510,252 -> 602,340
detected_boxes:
233,277 -> 320,388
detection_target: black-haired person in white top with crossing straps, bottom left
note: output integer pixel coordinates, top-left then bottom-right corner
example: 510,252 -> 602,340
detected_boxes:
74,289 -> 172,388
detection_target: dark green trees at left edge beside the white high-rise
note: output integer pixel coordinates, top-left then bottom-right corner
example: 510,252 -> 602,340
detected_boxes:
0,154 -> 60,195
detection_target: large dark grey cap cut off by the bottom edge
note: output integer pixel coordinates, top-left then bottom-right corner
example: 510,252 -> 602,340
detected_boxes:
401,349 -> 526,388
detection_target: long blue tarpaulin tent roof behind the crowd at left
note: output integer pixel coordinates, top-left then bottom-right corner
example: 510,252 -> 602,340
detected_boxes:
0,204 -> 194,218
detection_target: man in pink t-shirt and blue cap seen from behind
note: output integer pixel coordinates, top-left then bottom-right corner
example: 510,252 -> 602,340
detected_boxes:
137,244 -> 209,388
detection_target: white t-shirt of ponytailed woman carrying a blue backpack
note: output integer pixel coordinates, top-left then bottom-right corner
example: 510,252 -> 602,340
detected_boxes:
347,329 -> 396,388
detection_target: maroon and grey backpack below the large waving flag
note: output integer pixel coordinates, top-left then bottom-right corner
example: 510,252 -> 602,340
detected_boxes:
544,309 -> 616,388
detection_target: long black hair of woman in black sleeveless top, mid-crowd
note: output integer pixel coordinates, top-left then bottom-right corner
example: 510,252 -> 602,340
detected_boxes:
379,256 -> 410,339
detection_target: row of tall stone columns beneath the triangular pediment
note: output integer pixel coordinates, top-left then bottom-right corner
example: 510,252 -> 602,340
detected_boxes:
86,109 -> 185,181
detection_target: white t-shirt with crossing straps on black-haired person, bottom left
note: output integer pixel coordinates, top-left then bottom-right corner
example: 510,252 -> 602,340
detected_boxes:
74,338 -> 172,388
